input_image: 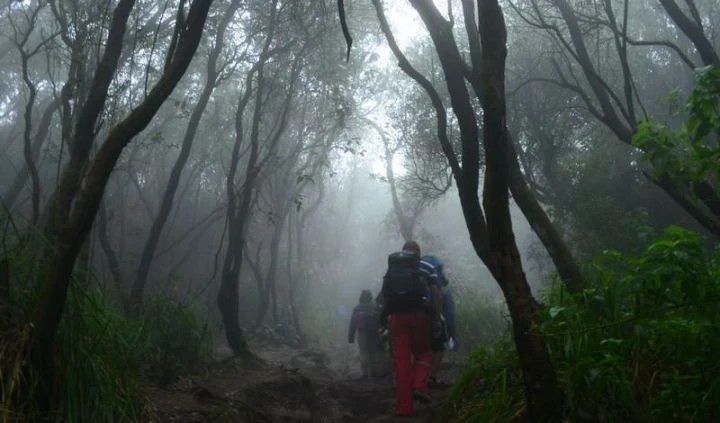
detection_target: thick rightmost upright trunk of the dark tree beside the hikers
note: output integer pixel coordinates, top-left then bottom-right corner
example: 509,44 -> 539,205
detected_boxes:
478,1 -> 563,421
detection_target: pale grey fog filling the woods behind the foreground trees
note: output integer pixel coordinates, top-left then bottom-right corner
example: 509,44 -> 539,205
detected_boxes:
0,0 -> 720,358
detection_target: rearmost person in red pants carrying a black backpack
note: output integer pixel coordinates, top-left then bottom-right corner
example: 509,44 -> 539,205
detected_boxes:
381,241 -> 441,416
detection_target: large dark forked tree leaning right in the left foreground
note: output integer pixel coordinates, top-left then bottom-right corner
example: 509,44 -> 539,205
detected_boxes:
27,0 -> 212,411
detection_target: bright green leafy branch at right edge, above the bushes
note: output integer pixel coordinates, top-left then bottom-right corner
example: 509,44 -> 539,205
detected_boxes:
633,66 -> 720,190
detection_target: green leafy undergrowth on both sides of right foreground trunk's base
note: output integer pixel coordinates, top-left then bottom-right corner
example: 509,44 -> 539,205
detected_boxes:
447,227 -> 720,421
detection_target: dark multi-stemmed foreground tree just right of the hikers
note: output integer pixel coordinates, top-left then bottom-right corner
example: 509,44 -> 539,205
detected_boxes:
366,0 -> 562,420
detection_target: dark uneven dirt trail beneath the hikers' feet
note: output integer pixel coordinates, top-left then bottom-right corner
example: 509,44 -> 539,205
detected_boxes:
144,342 -> 459,423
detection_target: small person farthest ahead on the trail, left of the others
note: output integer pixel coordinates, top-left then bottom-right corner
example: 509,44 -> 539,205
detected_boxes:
348,289 -> 380,378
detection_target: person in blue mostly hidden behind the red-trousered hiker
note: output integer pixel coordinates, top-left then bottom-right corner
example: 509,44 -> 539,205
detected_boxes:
422,255 -> 457,388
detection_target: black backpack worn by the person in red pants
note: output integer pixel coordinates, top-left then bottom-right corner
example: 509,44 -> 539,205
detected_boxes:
382,251 -> 427,313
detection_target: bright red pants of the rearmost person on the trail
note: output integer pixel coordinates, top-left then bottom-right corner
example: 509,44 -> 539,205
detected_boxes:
390,311 -> 432,414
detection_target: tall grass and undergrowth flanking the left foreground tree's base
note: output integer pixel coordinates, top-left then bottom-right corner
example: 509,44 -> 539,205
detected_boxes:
0,225 -> 210,422
